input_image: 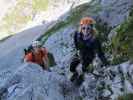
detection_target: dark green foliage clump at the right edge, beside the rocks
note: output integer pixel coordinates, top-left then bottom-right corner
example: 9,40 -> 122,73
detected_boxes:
112,10 -> 133,60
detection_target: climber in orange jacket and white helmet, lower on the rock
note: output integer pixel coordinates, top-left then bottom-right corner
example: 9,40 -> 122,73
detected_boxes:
24,41 -> 49,70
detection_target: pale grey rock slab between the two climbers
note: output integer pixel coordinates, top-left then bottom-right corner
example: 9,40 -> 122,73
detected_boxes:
45,26 -> 76,67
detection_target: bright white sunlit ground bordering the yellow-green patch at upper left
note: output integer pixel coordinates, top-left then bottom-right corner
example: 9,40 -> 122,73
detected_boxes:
0,0 -> 91,39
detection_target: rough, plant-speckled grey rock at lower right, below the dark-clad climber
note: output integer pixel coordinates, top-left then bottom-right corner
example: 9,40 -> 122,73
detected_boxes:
82,62 -> 133,100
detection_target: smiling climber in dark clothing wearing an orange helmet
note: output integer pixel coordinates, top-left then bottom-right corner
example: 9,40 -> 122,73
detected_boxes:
70,17 -> 108,84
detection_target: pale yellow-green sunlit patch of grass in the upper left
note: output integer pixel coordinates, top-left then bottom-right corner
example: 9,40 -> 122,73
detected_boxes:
0,0 -> 48,38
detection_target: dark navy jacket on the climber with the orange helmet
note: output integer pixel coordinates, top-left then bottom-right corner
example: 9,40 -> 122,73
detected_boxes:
74,32 -> 107,63
